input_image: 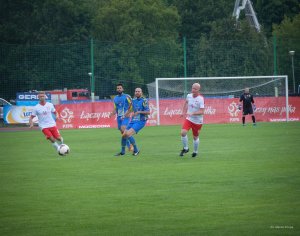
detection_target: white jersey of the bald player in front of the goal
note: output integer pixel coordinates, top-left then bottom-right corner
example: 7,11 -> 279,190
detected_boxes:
186,93 -> 204,124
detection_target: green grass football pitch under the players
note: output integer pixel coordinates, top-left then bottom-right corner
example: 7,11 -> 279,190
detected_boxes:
0,122 -> 300,236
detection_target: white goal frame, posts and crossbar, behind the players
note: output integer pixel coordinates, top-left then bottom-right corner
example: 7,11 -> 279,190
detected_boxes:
155,75 -> 289,125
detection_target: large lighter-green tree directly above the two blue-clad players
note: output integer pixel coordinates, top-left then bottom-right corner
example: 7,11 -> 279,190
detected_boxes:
92,0 -> 181,96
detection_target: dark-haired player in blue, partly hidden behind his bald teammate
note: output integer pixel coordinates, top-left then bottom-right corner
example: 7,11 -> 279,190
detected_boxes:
110,84 -> 133,155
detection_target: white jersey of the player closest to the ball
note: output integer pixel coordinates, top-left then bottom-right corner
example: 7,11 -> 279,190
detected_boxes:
32,102 -> 56,129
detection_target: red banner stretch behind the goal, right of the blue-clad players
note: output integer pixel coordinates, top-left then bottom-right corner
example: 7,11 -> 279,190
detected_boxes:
154,97 -> 300,125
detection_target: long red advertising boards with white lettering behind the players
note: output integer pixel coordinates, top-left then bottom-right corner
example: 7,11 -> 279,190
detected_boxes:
56,97 -> 300,128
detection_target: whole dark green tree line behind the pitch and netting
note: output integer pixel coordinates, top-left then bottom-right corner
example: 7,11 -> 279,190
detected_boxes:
0,0 -> 300,97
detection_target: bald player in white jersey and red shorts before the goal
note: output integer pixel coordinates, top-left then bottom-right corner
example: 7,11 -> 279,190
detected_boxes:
179,83 -> 204,157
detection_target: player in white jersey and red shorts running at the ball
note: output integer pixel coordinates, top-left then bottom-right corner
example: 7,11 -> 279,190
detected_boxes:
29,91 -> 63,150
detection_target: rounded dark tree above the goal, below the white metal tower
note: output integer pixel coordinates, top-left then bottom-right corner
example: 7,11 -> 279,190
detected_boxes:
190,18 -> 272,76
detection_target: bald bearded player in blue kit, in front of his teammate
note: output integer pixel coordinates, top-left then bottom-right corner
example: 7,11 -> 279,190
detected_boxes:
119,88 -> 150,156
